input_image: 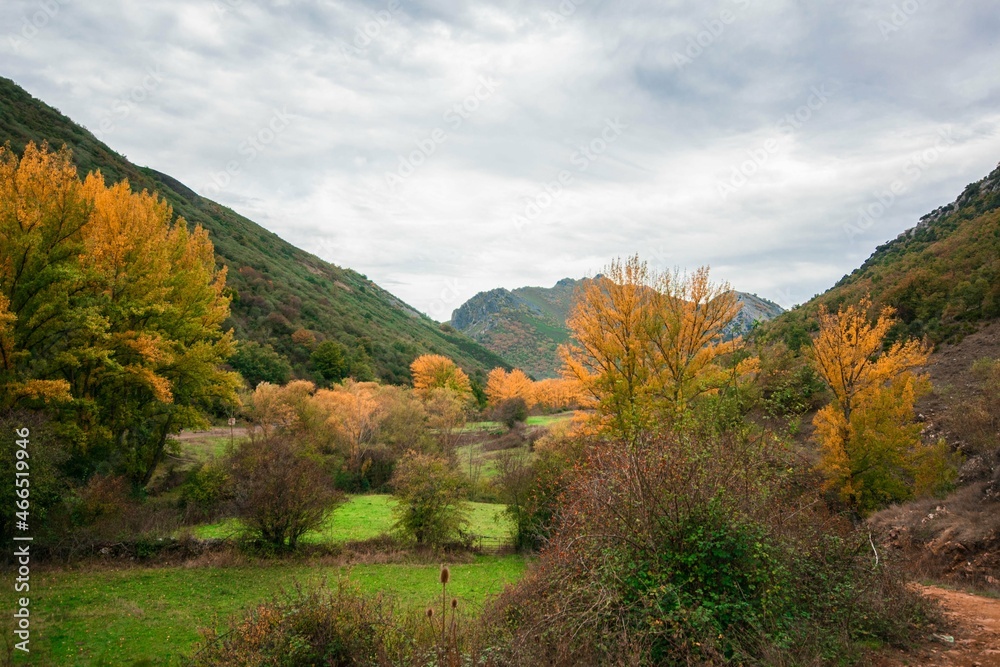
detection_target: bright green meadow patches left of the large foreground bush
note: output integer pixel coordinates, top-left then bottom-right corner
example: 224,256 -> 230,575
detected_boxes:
32,432 -> 526,666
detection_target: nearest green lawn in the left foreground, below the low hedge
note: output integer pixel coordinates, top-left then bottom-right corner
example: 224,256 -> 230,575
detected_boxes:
30,556 -> 525,666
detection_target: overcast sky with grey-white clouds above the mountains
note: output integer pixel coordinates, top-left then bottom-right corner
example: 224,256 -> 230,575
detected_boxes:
0,0 -> 1000,320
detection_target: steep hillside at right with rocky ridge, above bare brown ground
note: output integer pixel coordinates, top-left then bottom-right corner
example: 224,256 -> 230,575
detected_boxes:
769,166 -> 1000,344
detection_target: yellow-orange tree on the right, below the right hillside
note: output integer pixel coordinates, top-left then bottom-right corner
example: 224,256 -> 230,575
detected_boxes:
811,298 -> 953,515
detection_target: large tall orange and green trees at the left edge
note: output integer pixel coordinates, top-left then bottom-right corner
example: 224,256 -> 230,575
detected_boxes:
0,144 -> 237,486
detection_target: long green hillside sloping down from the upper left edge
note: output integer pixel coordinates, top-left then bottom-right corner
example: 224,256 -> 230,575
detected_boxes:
0,77 -> 509,383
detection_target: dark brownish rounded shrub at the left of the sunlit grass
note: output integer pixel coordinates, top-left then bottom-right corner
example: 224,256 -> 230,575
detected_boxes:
229,435 -> 343,549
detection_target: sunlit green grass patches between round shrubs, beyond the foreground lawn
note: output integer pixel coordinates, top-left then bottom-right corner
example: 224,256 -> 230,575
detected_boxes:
194,495 -> 512,543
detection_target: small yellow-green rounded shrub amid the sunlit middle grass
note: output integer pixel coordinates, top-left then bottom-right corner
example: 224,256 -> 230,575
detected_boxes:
392,450 -> 468,546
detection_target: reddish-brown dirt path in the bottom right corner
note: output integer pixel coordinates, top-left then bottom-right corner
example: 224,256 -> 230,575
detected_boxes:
876,586 -> 1000,667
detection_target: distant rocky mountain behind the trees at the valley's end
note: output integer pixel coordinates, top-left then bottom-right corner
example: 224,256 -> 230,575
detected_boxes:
451,278 -> 784,378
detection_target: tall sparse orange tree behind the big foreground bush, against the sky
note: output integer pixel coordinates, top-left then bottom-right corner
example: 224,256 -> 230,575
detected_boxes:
560,255 -> 740,442
